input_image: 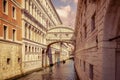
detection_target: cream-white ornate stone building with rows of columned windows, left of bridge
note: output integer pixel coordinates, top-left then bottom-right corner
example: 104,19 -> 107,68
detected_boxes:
22,0 -> 61,73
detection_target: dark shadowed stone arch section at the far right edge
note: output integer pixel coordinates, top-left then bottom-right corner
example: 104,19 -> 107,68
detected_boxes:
103,0 -> 120,80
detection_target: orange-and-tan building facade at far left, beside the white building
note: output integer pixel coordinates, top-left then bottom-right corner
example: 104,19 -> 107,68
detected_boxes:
0,0 -> 22,80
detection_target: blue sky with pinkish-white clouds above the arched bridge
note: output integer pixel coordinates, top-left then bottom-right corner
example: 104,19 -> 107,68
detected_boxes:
52,0 -> 78,28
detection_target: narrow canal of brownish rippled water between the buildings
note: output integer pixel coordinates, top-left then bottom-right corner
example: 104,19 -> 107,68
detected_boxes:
18,60 -> 78,80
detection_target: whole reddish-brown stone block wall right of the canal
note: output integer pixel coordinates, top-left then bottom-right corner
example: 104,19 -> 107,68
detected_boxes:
75,0 -> 120,80
